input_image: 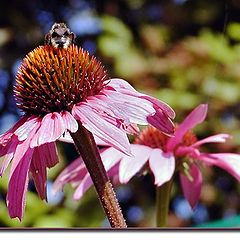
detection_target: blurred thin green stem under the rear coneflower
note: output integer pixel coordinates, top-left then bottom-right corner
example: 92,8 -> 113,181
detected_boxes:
156,179 -> 172,227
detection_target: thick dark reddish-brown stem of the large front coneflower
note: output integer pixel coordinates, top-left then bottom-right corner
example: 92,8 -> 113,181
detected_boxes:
71,122 -> 127,228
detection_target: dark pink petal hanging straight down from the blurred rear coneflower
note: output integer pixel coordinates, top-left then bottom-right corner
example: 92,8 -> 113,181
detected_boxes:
180,164 -> 202,208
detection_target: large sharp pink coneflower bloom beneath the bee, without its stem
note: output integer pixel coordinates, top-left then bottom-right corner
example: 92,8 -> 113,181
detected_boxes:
0,23 -> 174,219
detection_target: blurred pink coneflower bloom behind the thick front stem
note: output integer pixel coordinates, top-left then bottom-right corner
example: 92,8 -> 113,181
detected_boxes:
54,104 -> 240,208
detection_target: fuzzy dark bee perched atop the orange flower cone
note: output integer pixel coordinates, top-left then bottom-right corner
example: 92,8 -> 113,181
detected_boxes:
45,23 -> 76,48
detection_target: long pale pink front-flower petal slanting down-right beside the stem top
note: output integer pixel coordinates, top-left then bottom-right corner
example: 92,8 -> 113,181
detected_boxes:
72,104 -> 130,154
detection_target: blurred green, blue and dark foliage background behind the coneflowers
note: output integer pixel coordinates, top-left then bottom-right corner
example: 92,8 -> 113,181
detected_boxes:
0,0 -> 240,228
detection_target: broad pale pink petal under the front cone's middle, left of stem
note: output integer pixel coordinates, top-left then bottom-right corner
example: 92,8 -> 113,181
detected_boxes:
30,112 -> 66,148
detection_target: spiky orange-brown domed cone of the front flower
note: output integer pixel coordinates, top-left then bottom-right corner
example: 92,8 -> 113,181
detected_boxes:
14,45 -> 107,115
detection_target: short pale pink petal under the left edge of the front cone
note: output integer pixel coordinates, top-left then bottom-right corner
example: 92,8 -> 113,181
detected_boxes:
14,116 -> 41,141
